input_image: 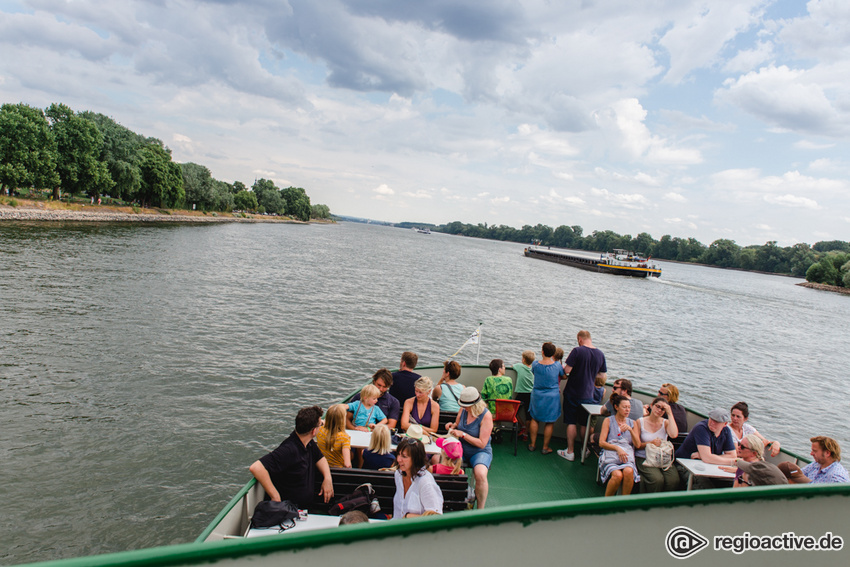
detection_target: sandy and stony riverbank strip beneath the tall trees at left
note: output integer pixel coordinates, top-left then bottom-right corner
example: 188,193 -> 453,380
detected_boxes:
0,199 -> 314,224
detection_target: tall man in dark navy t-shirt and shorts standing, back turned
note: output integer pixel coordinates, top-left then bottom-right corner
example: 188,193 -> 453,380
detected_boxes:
558,330 -> 608,461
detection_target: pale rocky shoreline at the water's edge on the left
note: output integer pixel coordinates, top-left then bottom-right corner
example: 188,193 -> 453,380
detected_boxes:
0,206 -> 307,224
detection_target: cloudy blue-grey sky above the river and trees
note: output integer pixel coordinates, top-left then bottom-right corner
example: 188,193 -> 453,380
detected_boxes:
0,0 -> 850,246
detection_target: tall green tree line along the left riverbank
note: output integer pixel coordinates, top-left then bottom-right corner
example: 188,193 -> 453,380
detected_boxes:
0,103 -> 331,221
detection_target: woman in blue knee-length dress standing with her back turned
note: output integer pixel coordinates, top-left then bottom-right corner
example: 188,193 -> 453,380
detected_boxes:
528,343 -> 564,455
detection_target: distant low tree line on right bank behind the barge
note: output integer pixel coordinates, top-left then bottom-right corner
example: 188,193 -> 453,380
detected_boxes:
410,221 -> 850,287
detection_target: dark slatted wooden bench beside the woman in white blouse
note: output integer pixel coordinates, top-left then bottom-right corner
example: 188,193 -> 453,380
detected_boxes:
310,468 -> 469,514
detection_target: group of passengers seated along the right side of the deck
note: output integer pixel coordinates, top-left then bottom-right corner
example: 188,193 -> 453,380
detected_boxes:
588,379 -> 850,496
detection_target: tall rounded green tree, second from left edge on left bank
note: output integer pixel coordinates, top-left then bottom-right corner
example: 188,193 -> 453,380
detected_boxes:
45,103 -> 115,198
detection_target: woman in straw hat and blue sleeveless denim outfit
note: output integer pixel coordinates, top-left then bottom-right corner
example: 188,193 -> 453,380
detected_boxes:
446,386 -> 493,509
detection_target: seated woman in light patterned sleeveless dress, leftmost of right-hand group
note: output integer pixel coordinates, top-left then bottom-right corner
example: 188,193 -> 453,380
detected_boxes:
599,394 -> 640,496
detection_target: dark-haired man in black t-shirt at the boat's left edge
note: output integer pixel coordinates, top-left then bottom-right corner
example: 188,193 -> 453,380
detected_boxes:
249,406 -> 334,508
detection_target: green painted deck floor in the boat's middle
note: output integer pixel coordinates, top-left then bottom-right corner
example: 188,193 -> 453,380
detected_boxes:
476,432 -> 605,508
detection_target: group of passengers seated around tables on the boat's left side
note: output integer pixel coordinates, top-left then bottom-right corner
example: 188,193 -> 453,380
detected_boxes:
245,352 -> 500,518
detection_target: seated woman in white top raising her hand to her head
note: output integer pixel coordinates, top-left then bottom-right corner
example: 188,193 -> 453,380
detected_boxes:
635,397 -> 679,493
